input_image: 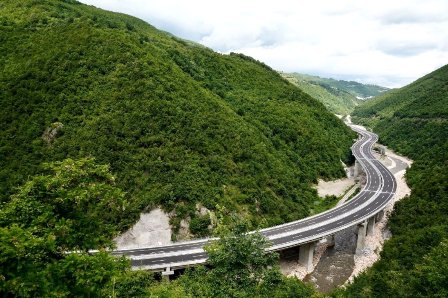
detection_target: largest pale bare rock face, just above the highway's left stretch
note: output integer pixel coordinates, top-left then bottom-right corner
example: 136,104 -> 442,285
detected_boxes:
115,208 -> 171,249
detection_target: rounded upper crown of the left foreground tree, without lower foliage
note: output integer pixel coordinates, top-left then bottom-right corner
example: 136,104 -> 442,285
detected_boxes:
0,158 -> 127,252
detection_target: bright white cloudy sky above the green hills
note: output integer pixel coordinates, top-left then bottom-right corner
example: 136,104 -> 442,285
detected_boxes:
81,0 -> 448,87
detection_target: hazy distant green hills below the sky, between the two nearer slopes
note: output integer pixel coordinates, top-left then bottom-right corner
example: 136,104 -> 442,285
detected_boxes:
281,73 -> 389,115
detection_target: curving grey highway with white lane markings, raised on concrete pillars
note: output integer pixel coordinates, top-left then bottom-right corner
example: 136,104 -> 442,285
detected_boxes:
112,126 -> 397,271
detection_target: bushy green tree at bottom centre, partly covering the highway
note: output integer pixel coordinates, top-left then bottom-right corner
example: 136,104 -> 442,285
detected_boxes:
147,218 -> 317,298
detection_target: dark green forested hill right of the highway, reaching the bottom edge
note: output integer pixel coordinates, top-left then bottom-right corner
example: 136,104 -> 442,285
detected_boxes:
341,66 -> 448,297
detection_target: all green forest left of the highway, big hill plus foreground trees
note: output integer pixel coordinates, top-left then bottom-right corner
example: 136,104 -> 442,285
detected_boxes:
0,0 -> 355,297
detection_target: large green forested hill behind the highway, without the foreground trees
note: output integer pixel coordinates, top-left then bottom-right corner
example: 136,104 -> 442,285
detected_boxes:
0,0 -> 354,235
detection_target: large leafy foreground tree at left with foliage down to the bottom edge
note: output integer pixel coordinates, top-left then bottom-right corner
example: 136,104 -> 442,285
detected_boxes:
0,158 -> 130,297
